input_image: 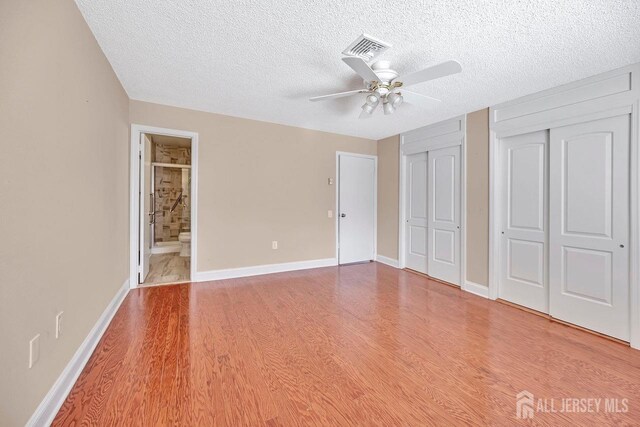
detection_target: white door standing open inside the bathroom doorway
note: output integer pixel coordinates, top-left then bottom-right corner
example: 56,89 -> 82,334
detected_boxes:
138,134 -> 153,283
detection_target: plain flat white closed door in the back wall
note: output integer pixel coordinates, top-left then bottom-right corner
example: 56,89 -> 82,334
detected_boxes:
338,154 -> 376,264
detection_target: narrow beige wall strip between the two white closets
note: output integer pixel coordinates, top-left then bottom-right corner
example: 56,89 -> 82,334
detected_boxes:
466,108 -> 489,286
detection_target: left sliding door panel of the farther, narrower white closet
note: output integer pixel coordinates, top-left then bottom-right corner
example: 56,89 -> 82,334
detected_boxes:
405,152 -> 427,274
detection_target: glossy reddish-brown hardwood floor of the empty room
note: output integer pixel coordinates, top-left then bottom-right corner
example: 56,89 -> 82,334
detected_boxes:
54,263 -> 640,426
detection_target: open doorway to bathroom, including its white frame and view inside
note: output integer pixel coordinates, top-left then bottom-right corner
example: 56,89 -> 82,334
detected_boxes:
130,125 -> 197,287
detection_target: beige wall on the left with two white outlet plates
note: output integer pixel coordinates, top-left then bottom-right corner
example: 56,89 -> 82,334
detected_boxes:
0,0 -> 129,426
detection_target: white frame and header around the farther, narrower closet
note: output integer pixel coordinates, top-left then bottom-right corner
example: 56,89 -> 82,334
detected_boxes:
398,115 -> 468,293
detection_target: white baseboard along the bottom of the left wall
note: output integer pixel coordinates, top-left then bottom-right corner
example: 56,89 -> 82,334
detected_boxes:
27,279 -> 129,426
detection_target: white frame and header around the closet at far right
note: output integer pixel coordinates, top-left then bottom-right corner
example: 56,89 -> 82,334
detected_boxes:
489,64 -> 640,349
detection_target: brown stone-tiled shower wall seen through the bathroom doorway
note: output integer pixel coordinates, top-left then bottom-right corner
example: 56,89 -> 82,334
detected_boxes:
154,144 -> 191,242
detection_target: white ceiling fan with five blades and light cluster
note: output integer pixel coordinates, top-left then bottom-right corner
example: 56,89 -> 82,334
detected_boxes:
309,56 -> 462,119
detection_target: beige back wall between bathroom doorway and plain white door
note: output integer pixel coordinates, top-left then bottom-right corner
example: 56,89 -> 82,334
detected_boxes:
130,101 -> 376,271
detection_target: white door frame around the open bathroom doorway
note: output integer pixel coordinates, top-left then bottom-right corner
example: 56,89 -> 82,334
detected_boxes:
129,124 -> 198,289
